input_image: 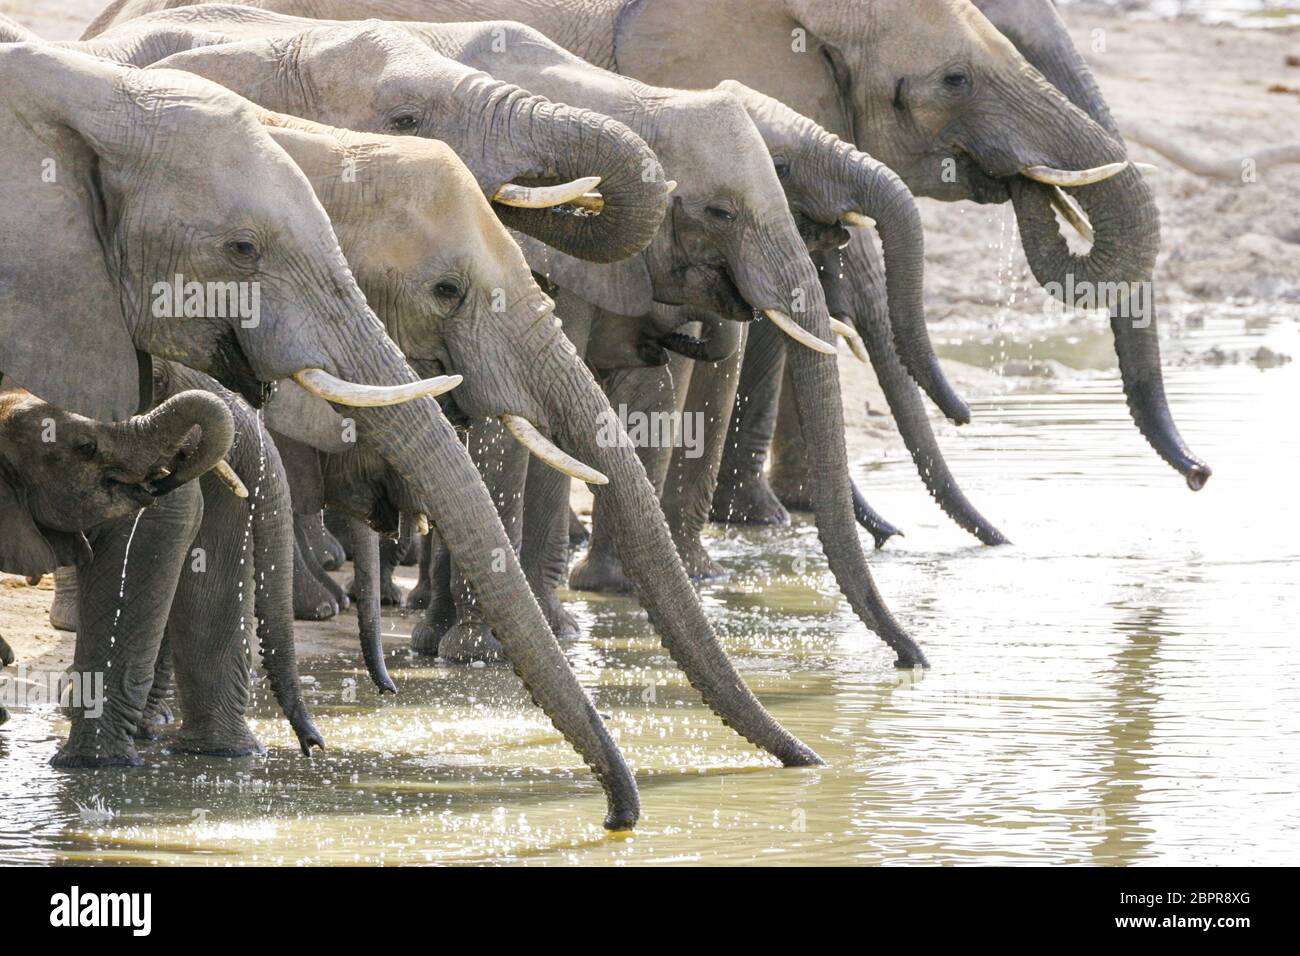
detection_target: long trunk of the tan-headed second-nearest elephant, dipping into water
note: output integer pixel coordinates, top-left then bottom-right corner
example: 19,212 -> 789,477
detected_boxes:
538,332 -> 822,766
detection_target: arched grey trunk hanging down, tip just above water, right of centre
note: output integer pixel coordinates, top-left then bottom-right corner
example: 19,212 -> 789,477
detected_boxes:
823,133 -> 971,425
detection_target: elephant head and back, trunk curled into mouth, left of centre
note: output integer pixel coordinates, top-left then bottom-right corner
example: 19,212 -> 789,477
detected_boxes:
86,7 -> 667,263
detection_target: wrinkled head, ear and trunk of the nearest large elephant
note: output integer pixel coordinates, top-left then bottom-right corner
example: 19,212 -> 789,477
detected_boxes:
0,44 -> 638,827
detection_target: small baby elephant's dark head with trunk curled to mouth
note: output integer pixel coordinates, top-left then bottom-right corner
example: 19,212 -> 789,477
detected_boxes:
0,389 -> 234,575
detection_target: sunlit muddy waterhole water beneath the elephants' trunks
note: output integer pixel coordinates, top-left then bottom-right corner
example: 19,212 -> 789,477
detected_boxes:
0,319 -> 1300,865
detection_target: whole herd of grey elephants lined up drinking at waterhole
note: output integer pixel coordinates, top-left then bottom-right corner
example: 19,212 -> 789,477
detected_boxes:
0,0 -> 1210,829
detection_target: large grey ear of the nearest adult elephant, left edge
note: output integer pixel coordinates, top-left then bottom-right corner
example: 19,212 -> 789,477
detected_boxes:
0,53 -> 144,420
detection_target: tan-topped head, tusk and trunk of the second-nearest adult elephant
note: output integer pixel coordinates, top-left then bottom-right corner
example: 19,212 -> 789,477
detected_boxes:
250,117 -> 819,765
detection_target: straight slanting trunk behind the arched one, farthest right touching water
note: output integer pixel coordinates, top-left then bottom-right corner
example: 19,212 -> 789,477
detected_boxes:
814,235 -> 1008,545
